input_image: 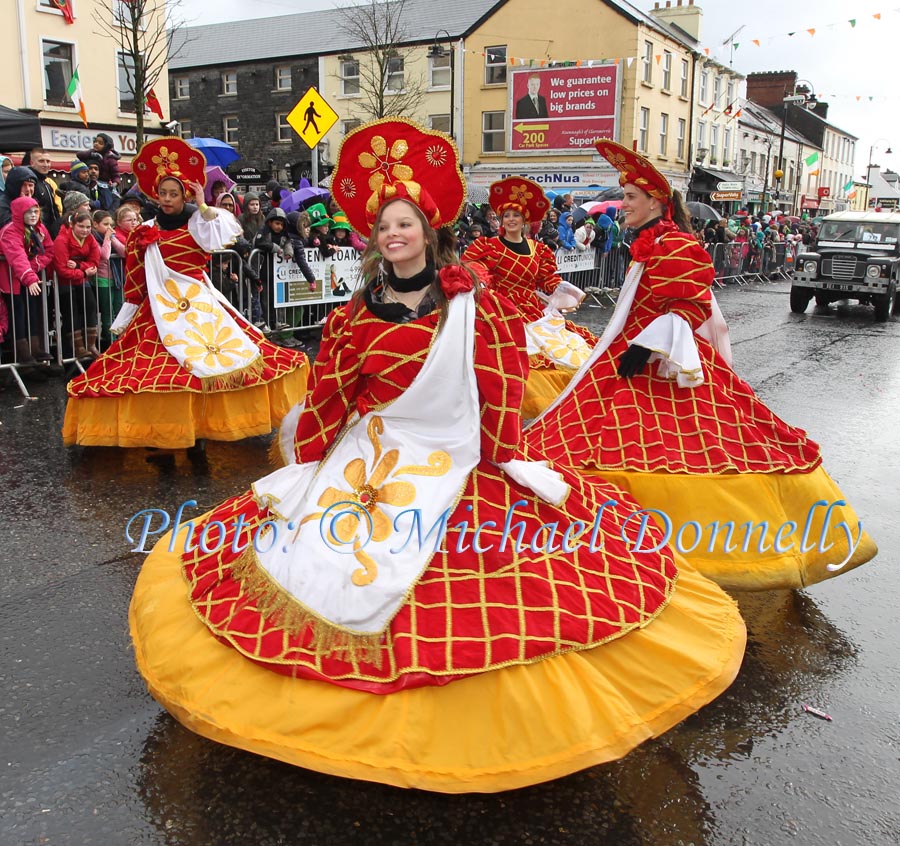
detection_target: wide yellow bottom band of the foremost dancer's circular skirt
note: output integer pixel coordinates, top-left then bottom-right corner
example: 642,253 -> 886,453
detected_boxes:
129,535 -> 746,793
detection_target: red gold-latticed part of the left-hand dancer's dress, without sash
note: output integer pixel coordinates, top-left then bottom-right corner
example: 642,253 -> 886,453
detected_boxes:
68,226 -> 306,397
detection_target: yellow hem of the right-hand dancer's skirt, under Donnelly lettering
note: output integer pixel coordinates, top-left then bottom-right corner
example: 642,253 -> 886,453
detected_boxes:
586,465 -> 878,590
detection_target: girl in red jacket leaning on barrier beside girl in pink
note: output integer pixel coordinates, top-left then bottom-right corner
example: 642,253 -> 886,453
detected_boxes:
53,212 -> 100,358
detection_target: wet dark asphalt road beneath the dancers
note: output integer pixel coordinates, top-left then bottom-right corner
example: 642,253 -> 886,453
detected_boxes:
0,283 -> 900,846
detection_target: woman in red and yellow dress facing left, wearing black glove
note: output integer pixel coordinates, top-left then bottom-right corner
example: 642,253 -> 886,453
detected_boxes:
525,140 -> 876,589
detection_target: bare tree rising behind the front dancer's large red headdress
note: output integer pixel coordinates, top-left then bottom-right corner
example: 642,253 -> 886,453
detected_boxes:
337,0 -> 425,120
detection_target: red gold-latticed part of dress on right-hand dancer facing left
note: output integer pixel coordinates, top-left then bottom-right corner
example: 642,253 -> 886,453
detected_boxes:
525,231 -> 821,474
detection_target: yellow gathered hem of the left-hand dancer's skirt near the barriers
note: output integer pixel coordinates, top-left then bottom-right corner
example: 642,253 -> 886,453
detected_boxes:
62,366 -> 309,449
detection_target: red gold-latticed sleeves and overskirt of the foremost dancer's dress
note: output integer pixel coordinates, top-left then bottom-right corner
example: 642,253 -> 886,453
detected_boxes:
184,292 -> 675,693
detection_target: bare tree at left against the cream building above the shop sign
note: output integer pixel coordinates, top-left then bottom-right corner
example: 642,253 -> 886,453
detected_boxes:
93,0 -> 187,147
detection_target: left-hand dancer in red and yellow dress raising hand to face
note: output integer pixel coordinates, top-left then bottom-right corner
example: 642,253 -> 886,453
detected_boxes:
63,138 -> 309,449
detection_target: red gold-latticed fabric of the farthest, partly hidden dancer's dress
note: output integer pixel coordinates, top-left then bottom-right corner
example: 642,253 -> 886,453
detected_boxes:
463,238 -> 597,346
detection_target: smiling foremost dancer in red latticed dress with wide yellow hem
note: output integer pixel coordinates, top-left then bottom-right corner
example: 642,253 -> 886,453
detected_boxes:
130,119 -> 744,792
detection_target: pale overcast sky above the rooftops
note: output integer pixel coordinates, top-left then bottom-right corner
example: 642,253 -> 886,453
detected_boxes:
180,0 -> 900,179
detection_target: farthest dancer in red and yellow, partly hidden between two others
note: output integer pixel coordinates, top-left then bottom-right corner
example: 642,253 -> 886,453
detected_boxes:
464,176 -> 597,419
